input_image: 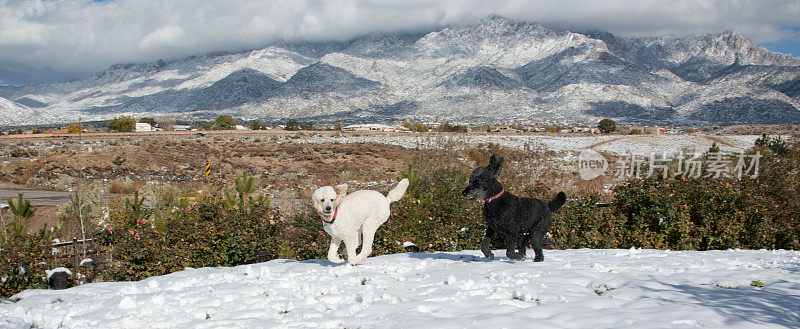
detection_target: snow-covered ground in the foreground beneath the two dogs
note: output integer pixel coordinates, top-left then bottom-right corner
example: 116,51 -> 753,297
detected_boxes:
0,249 -> 800,328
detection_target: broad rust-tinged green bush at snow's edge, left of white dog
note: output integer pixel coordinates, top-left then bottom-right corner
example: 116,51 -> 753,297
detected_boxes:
99,195 -> 280,280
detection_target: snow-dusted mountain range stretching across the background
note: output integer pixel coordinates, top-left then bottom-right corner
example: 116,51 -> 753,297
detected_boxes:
0,17 -> 800,126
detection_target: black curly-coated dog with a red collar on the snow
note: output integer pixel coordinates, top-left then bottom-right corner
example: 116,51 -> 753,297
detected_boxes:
461,154 -> 567,262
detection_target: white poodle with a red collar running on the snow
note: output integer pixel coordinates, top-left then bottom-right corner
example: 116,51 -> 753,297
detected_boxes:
312,178 -> 408,265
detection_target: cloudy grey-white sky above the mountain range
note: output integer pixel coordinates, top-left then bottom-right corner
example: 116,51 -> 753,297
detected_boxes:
0,0 -> 800,84
